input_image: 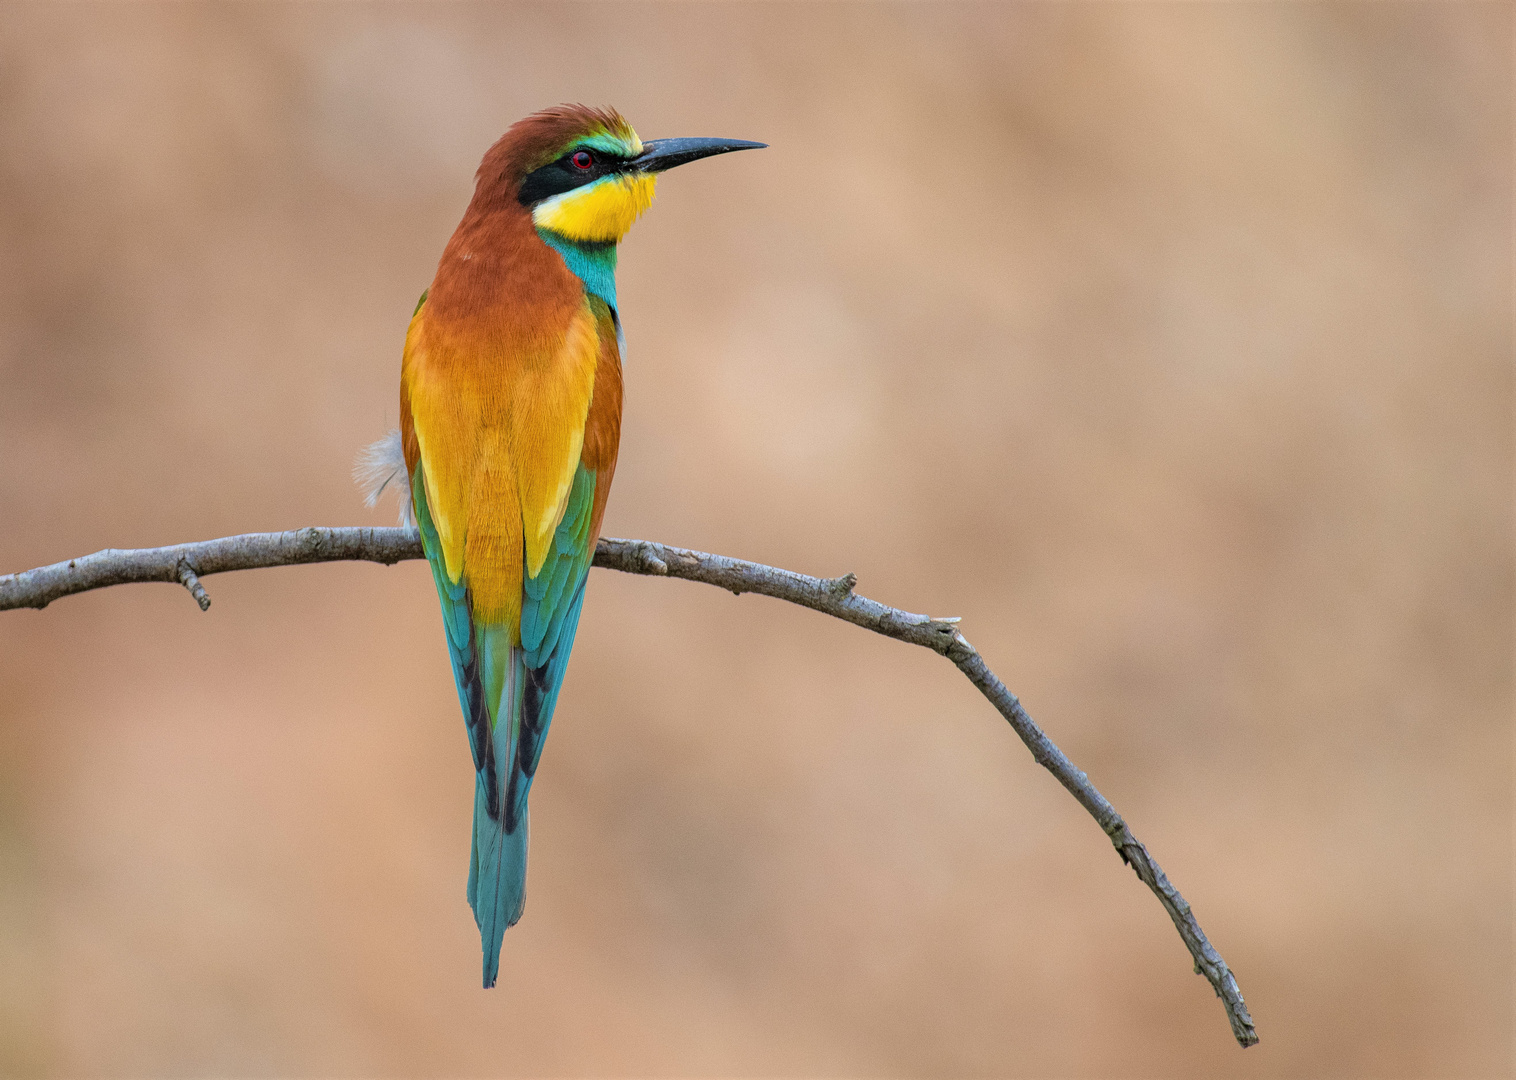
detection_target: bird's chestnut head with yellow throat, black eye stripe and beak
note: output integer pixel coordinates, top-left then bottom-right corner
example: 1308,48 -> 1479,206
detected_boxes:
476,105 -> 766,244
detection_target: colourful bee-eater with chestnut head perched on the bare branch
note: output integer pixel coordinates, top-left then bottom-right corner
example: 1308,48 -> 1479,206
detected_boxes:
356,105 -> 766,989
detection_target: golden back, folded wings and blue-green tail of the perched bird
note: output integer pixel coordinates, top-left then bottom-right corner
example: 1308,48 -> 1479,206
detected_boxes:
400,280 -> 622,986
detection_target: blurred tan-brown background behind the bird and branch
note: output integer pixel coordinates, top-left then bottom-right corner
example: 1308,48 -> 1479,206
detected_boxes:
0,3 -> 1513,1077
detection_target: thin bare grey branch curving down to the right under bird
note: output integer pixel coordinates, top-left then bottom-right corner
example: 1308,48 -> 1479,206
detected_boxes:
0,528 -> 1258,1047
